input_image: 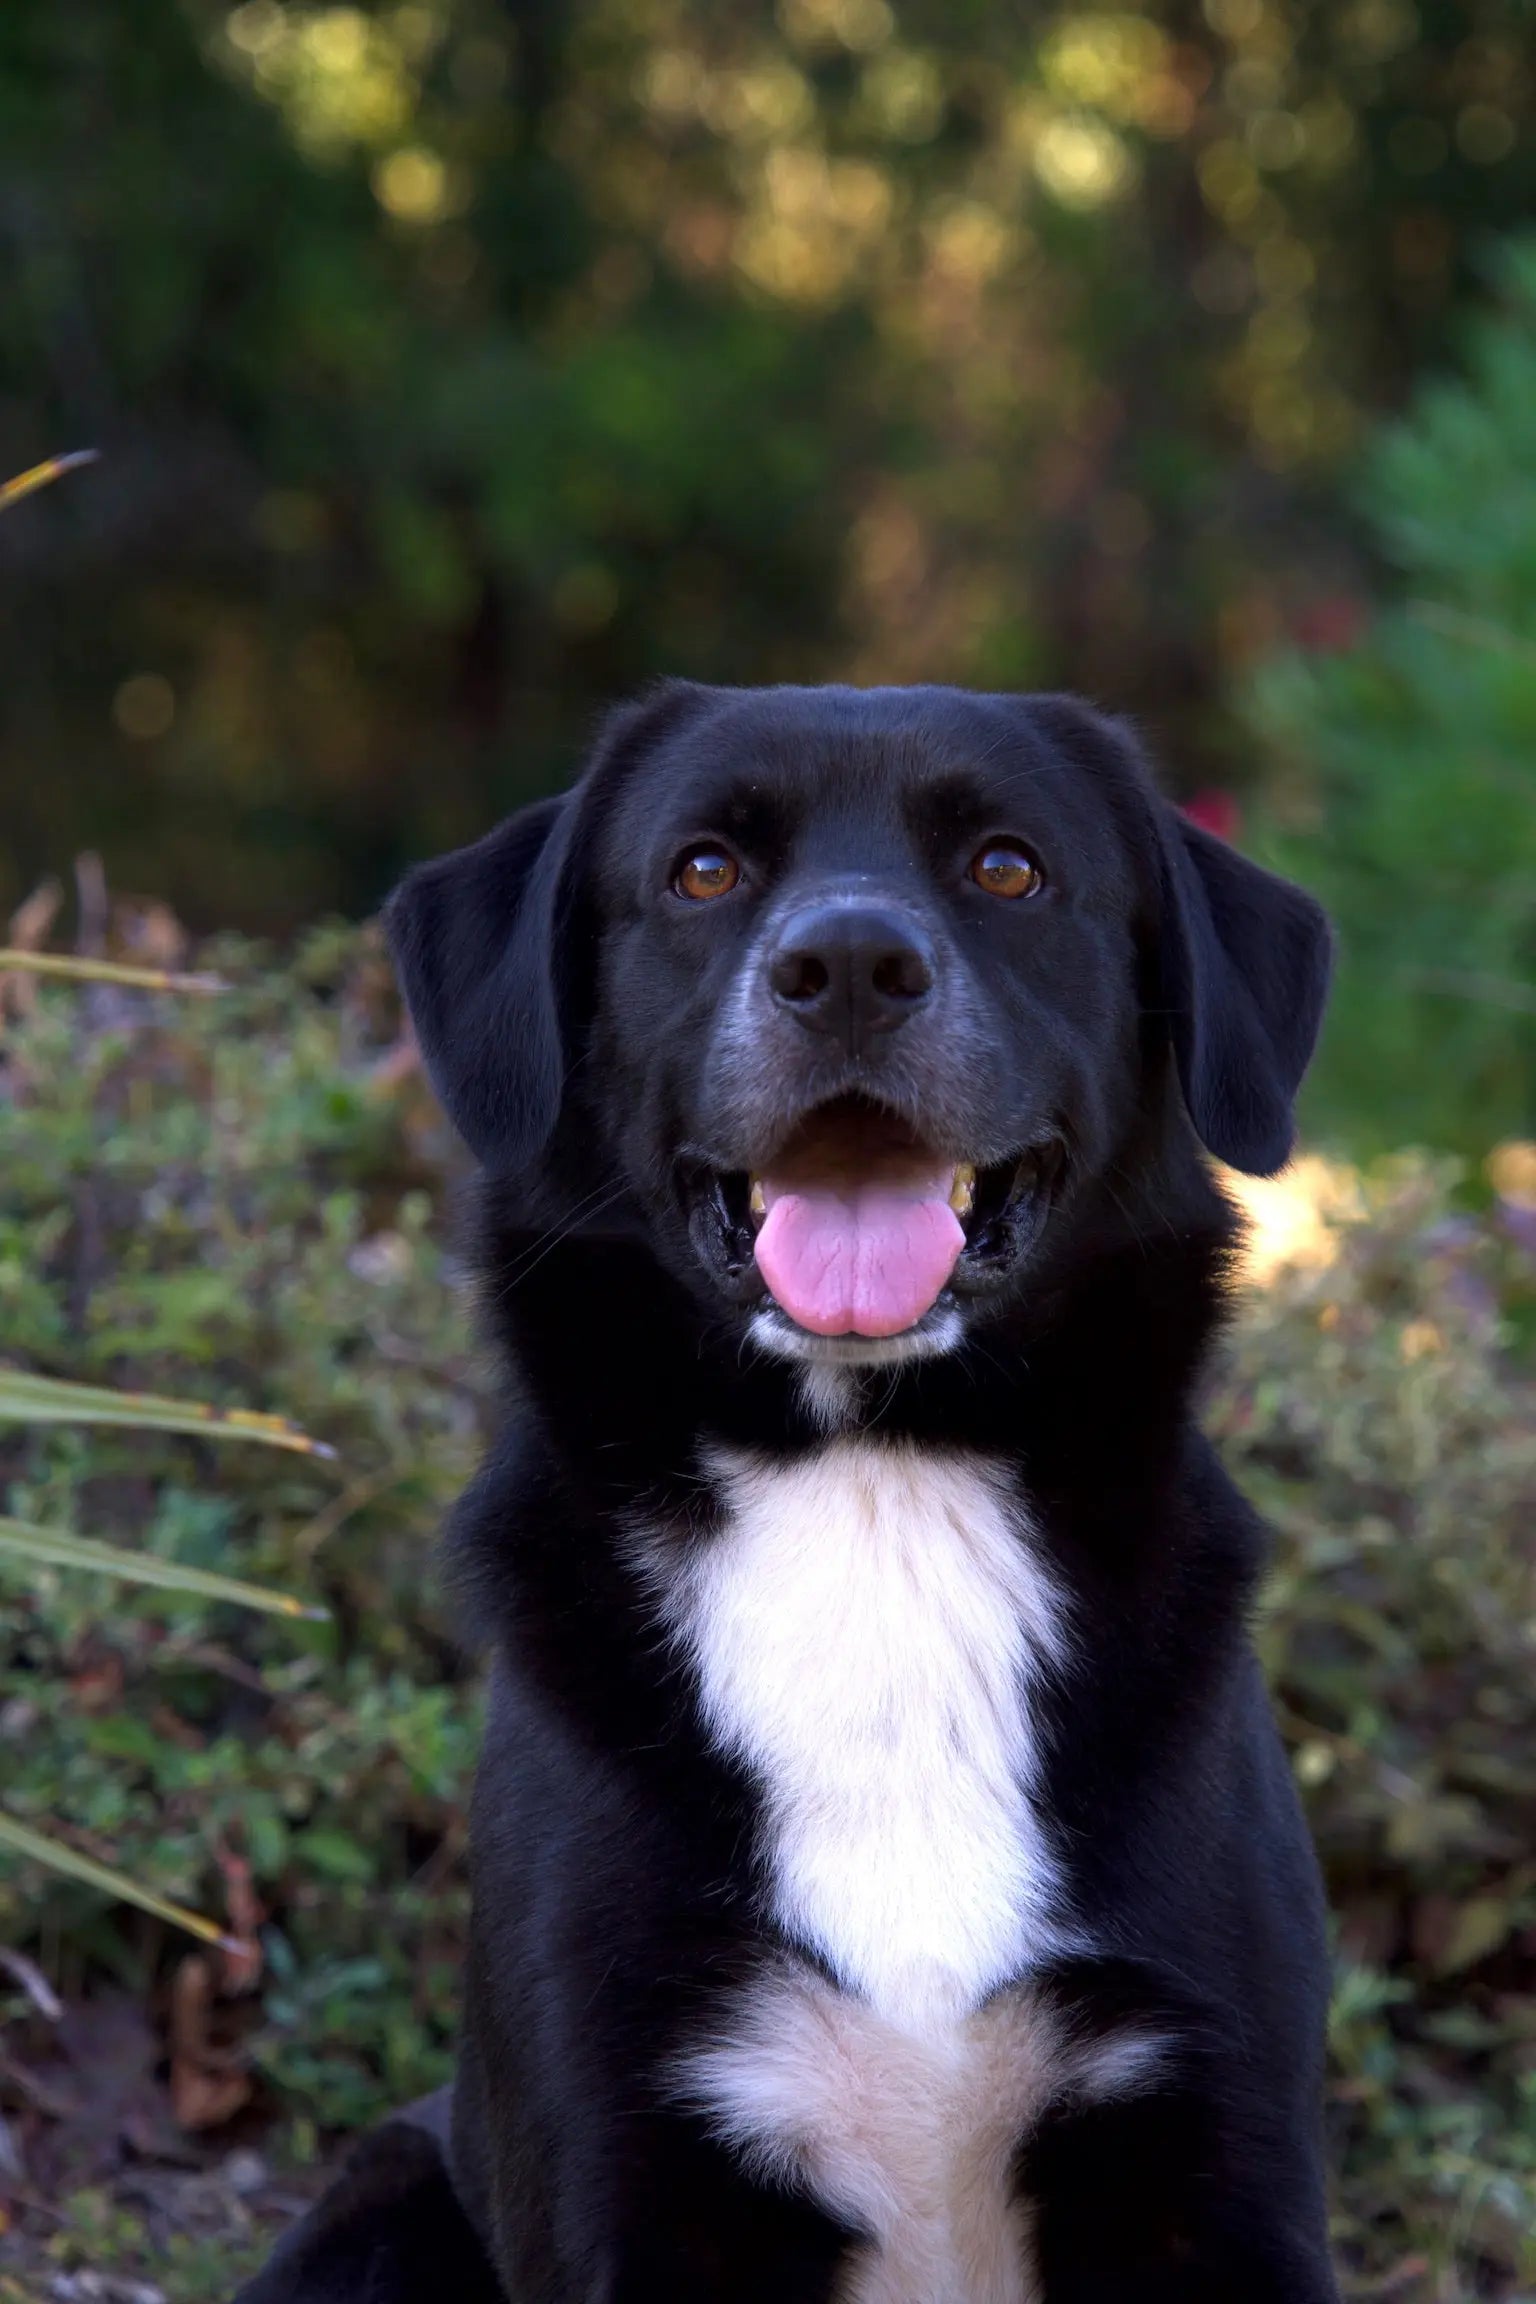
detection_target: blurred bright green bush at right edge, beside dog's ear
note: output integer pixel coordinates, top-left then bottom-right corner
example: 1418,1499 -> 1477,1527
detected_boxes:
1248,240 -> 1536,1152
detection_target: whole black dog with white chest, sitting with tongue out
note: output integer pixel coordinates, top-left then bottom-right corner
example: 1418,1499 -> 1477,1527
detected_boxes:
237,684 -> 1336,2304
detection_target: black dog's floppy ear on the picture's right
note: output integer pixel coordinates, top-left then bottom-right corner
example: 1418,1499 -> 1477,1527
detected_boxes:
1154,799 -> 1333,1175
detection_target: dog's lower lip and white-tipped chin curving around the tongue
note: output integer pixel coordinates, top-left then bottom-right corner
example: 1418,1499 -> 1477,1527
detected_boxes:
679,1115 -> 1064,1369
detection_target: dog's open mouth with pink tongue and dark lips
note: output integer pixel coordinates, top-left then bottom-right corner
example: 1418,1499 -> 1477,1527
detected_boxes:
714,1099 -> 1045,1336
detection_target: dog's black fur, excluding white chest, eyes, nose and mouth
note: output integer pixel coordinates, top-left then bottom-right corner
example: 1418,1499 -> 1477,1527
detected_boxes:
246,684 -> 1336,2304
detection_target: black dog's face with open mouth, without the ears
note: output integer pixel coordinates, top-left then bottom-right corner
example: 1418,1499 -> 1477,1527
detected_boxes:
594,689 -> 1151,1359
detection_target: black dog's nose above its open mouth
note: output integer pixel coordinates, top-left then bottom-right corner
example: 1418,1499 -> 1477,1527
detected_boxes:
769,903 -> 935,1048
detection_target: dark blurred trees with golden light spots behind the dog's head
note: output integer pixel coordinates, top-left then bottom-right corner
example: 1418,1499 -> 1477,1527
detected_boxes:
0,0 -> 1536,926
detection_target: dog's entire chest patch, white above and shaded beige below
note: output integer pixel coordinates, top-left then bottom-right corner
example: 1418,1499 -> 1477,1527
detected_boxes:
649,1438 -> 1073,2304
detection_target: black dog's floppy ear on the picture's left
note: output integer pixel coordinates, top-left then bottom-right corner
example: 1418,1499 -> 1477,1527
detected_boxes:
385,680 -> 709,1175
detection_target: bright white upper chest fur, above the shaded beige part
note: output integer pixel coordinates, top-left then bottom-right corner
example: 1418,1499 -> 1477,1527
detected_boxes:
652,1438 -> 1066,2028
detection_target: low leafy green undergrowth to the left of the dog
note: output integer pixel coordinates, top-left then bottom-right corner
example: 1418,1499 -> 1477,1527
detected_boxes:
0,935 -> 479,2124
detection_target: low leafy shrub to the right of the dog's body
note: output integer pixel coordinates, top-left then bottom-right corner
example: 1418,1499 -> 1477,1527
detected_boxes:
1209,1159 -> 1536,2276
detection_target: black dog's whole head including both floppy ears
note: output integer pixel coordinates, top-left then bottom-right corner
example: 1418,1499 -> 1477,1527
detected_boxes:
389,684 -> 1329,1362
